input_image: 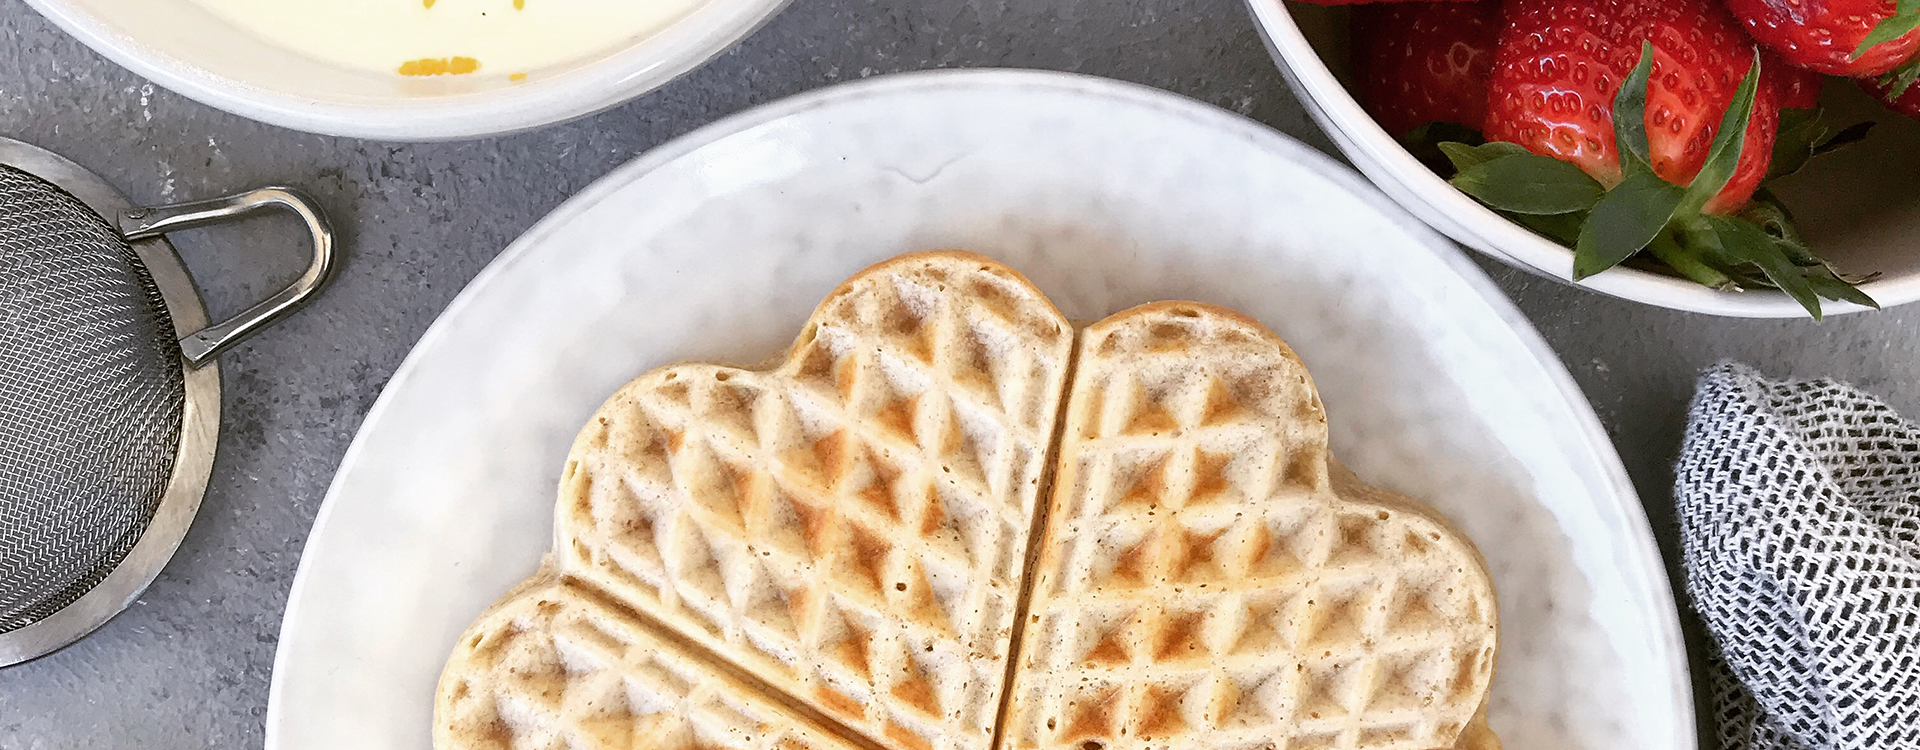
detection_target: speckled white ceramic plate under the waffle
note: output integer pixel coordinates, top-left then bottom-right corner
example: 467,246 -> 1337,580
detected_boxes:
267,71 -> 1695,750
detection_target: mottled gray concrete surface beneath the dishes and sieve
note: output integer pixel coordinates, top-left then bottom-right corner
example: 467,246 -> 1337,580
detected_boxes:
0,0 -> 1920,750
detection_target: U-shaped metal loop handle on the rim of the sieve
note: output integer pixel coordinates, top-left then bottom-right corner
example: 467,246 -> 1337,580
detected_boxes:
121,188 -> 338,364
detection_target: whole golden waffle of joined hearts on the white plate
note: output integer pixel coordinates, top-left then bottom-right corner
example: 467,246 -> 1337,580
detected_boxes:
434,251 -> 1496,750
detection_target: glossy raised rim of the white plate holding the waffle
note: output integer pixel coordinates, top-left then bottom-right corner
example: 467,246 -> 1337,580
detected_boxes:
265,67 -> 1697,750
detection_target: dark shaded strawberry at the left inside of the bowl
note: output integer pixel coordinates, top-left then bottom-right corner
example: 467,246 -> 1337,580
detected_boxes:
1354,0 -> 1500,136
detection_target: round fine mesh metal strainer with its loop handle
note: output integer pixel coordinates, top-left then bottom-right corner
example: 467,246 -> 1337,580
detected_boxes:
0,138 -> 334,666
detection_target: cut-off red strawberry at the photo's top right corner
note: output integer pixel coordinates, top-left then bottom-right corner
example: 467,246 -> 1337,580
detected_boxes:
1726,0 -> 1920,77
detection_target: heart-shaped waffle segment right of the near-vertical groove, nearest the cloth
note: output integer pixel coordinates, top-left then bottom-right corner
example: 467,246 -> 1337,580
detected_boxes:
1006,303 -> 1498,750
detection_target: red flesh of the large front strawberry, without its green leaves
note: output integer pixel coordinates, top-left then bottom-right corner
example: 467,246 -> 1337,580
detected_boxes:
1486,0 -> 1780,213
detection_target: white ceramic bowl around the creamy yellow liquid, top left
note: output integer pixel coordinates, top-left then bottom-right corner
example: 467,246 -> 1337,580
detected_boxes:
27,0 -> 787,140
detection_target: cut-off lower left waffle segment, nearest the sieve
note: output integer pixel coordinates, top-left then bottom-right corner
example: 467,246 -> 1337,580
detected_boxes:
434,579 -> 858,750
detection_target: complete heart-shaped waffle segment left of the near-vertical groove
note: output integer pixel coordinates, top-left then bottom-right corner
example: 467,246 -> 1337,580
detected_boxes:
557,253 -> 1073,750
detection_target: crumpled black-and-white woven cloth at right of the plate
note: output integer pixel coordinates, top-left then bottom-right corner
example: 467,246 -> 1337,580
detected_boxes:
1674,364 -> 1920,750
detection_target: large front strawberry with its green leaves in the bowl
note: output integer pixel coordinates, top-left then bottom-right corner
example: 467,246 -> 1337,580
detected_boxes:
1440,0 -> 1873,318
